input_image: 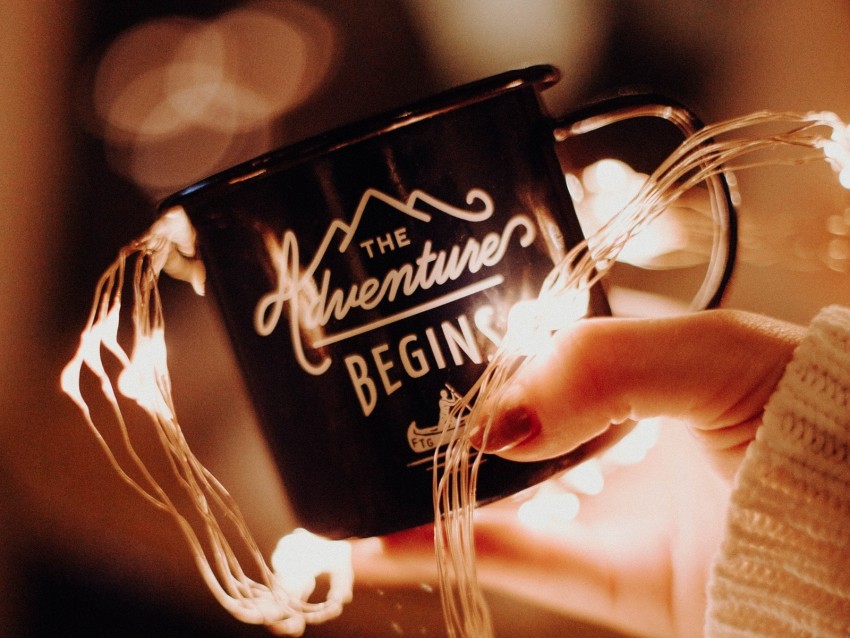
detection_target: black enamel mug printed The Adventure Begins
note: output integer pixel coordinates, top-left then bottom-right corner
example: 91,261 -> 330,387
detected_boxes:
160,65 -> 734,539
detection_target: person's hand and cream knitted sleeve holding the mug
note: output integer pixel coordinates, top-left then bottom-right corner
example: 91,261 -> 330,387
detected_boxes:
358,306 -> 850,637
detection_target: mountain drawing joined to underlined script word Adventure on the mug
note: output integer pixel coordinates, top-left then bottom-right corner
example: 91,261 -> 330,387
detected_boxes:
254,189 -> 537,374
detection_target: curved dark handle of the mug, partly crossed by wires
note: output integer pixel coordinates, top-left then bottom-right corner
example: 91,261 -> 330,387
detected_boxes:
553,95 -> 738,310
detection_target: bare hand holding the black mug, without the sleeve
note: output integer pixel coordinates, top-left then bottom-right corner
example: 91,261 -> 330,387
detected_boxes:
355,311 -> 803,636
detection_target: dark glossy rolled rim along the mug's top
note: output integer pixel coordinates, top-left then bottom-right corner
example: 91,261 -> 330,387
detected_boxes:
157,64 -> 561,211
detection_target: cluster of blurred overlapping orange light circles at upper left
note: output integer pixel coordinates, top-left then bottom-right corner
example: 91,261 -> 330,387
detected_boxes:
93,3 -> 336,196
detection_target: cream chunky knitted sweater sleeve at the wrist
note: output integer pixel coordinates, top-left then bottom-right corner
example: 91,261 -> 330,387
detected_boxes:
705,306 -> 850,637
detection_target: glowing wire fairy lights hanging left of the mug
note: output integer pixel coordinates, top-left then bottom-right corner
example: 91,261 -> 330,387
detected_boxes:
60,219 -> 354,636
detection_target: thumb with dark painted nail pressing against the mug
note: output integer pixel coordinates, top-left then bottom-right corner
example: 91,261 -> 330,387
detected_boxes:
485,310 -> 803,460
